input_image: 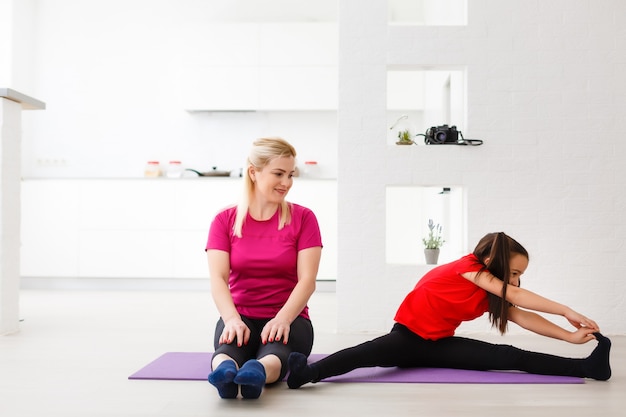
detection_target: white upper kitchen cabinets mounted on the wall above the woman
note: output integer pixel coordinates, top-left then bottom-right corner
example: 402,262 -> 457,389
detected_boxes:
180,23 -> 338,111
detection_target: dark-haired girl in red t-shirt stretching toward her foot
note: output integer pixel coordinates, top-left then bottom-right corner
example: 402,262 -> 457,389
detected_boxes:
287,233 -> 611,389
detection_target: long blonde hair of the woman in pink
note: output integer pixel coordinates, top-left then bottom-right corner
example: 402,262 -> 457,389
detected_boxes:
233,137 -> 296,238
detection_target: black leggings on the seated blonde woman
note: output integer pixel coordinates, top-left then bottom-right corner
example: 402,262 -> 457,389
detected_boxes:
213,316 -> 313,381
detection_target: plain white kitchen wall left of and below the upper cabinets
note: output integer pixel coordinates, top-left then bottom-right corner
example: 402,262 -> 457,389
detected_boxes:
20,0 -> 337,178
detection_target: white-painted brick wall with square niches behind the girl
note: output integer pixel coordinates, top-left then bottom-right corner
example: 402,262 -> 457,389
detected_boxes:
337,0 -> 626,334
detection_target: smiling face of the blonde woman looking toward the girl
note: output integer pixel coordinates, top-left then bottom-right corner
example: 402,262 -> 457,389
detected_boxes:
250,156 -> 296,204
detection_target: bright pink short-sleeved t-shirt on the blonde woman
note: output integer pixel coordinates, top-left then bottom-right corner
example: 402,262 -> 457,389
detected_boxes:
206,203 -> 322,318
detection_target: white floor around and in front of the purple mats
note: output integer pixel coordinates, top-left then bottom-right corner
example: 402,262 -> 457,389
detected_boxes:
0,290 -> 626,417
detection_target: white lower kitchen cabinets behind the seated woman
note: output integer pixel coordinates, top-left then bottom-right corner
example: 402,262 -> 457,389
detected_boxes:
21,178 -> 337,280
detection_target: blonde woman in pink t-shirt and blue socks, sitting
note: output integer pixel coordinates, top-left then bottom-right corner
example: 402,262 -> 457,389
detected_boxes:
206,138 -> 322,398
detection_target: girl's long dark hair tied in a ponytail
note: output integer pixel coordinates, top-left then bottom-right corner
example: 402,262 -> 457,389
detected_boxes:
474,232 -> 528,334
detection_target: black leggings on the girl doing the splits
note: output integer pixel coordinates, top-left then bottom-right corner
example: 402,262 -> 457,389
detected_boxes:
312,323 -> 585,382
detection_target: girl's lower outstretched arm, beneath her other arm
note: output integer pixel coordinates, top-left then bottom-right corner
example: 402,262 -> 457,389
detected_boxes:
509,307 -> 596,344
